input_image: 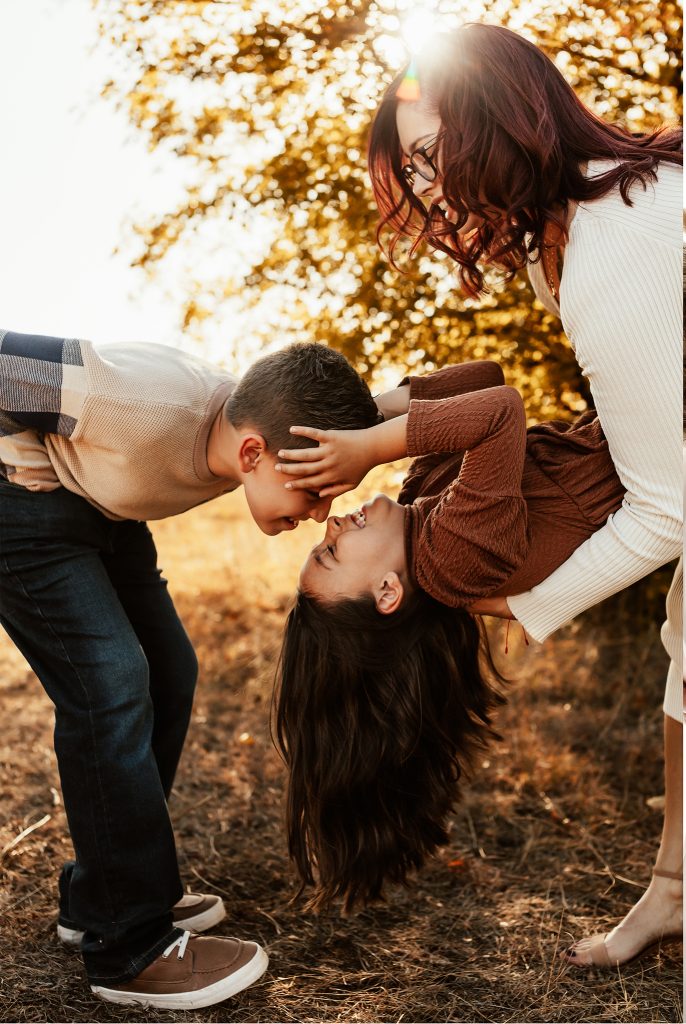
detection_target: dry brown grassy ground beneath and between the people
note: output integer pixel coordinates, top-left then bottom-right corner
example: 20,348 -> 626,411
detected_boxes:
0,495 -> 683,1024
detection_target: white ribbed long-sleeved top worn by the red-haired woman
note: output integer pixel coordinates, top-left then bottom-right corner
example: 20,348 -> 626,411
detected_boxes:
508,161 -> 683,641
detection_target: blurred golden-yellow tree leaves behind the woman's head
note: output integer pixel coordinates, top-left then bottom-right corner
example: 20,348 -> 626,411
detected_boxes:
93,0 -> 681,417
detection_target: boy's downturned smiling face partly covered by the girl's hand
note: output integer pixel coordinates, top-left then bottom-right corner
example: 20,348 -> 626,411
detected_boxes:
243,452 -> 332,537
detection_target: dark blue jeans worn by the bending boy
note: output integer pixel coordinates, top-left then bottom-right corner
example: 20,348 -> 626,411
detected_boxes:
0,478 -> 198,984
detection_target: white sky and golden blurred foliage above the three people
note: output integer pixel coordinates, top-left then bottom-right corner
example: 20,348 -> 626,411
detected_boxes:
0,0 -> 681,418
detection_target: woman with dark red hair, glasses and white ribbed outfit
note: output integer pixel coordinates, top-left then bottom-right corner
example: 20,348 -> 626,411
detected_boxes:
288,25 -> 683,967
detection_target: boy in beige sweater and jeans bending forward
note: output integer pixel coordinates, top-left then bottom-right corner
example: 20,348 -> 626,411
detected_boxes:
0,331 -> 378,1009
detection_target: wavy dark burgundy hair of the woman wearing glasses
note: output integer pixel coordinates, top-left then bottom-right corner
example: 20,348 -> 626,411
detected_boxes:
368,23 -> 683,296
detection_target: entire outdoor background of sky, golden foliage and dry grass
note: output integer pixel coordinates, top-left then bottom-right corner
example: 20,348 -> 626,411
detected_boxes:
0,0 -> 683,1022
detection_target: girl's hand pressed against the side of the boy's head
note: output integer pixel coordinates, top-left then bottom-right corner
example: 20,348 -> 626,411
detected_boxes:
275,427 -> 375,498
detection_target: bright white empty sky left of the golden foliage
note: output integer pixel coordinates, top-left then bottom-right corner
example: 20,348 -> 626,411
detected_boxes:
0,0 -> 188,352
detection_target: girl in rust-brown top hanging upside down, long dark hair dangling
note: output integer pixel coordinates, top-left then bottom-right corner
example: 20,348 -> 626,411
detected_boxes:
276,362 -> 624,906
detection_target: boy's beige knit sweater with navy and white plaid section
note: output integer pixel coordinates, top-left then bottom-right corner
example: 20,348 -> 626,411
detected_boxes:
0,331 -> 239,519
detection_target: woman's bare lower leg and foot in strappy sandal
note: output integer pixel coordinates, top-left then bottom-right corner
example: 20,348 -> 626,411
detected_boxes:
562,715 -> 683,967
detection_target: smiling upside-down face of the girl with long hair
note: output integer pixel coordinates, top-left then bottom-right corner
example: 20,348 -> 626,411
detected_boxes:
299,495 -> 406,601
